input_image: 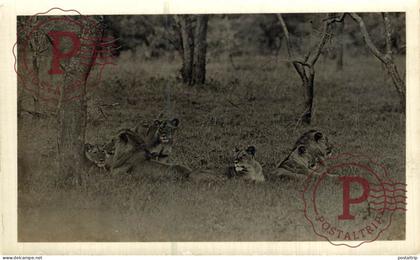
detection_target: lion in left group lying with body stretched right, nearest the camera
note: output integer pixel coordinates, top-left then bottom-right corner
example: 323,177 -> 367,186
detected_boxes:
111,129 -> 191,179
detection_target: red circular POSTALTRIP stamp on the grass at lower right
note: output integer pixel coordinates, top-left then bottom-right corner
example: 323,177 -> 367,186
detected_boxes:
302,153 -> 406,247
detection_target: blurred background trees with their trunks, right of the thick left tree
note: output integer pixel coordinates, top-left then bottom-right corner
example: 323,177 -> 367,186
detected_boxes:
100,13 -> 405,124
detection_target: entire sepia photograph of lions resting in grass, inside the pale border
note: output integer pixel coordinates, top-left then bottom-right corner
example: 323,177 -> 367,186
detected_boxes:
14,11 -> 406,244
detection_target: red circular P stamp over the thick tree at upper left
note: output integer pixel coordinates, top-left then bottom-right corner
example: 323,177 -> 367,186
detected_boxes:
13,8 -> 116,103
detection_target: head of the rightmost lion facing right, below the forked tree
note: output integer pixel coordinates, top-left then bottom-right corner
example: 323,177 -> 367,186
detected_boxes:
296,130 -> 333,162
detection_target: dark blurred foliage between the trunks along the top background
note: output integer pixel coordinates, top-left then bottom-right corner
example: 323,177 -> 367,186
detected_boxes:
101,13 -> 405,62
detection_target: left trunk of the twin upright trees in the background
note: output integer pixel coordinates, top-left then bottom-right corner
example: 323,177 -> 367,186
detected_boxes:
179,15 -> 194,85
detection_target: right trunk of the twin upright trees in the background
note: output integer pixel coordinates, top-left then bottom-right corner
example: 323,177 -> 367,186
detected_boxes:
193,15 -> 209,84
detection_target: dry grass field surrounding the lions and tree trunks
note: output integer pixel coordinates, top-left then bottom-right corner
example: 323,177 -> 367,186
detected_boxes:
18,53 -> 405,241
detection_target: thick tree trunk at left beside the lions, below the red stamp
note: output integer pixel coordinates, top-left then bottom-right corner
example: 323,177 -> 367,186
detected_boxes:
57,18 -> 102,185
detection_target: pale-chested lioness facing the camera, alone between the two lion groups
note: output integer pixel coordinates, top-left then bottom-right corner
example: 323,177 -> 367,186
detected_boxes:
227,146 -> 265,182
